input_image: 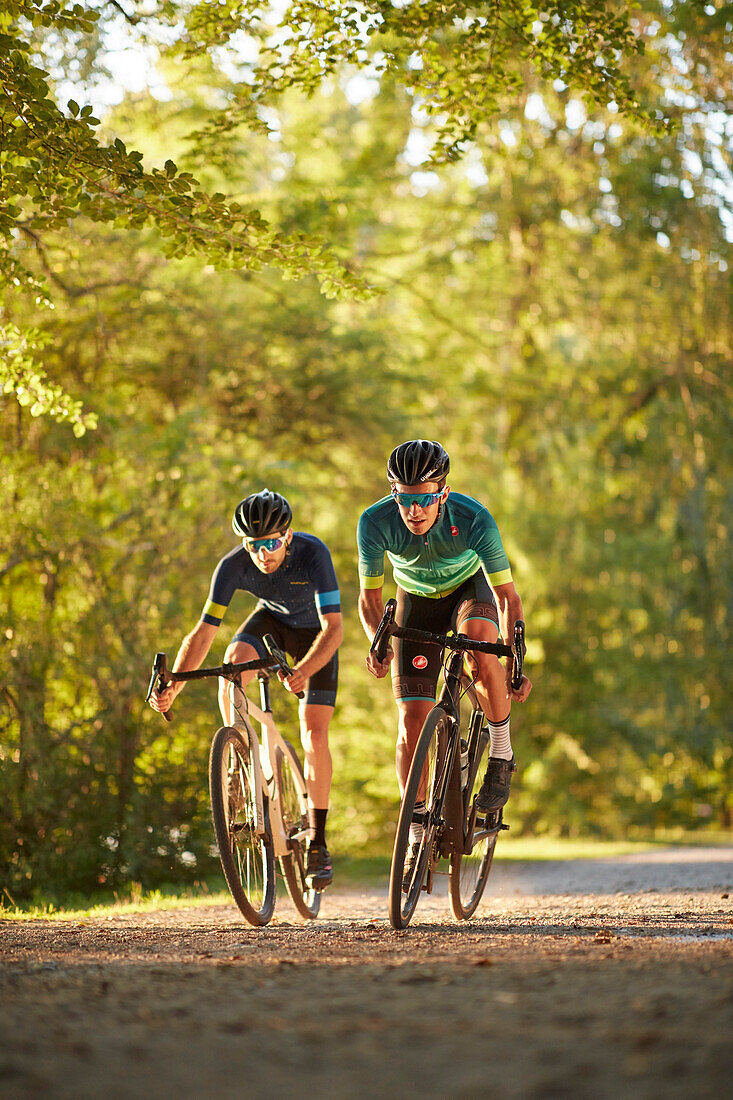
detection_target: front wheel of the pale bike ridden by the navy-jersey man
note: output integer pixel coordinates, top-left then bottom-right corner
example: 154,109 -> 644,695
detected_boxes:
209,726 -> 275,927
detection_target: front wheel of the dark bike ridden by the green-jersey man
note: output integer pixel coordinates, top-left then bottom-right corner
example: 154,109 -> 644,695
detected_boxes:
390,705 -> 452,928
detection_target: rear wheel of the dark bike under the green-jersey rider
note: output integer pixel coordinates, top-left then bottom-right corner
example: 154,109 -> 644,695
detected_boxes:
448,696 -> 501,921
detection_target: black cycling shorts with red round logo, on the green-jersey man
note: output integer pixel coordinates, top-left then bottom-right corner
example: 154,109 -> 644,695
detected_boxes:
392,570 -> 499,700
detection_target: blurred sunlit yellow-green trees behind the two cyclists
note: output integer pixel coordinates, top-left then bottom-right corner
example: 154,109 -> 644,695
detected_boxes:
0,2 -> 733,899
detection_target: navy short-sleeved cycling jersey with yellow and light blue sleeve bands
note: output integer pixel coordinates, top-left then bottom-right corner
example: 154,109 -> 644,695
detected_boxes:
201,531 -> 341,629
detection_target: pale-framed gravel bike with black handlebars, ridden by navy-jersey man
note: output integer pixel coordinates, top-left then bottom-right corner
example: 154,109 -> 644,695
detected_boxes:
147,635 -> 320,927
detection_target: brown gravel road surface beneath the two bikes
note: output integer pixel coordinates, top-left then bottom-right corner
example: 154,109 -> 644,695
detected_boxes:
0,847 -> 733,1100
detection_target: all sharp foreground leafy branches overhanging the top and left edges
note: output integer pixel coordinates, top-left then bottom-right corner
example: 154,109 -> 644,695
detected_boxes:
0,0 -> 658,432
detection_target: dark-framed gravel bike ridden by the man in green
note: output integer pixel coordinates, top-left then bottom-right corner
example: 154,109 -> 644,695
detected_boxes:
371,600 -> 524,928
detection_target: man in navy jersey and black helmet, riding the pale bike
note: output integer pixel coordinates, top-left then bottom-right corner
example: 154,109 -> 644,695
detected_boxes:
151,488 -> 342,890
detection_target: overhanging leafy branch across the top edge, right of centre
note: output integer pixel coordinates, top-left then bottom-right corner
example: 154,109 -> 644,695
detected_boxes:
182,0 -> 651,161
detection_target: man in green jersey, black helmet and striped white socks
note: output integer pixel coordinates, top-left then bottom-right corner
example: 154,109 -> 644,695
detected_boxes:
357,439 -> 532,862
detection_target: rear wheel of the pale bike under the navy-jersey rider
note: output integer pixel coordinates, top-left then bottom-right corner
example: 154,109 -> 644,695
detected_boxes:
275,743 -> 320,921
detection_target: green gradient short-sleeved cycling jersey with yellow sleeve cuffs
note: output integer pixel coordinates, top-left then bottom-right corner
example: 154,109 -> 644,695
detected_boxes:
357,493 -> 512,597
